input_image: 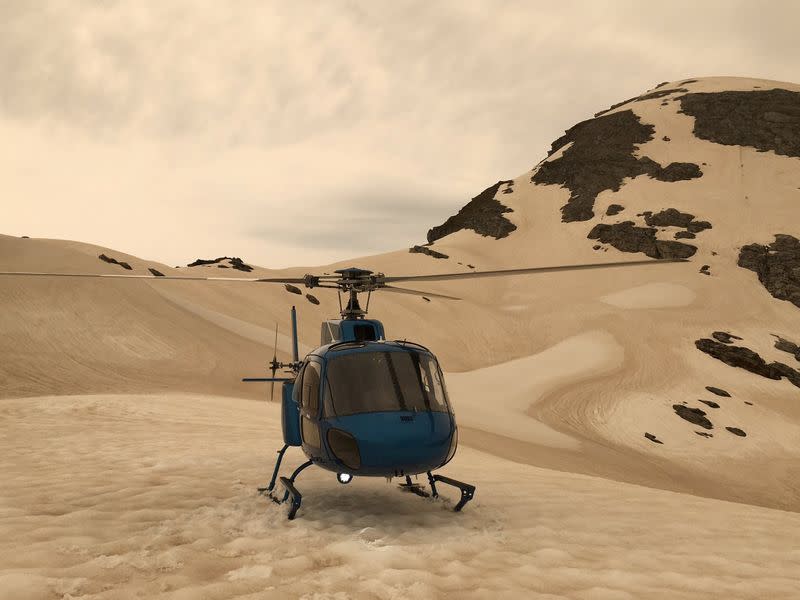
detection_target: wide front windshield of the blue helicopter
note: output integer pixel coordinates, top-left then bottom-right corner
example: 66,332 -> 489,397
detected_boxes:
325,350 -> 448,416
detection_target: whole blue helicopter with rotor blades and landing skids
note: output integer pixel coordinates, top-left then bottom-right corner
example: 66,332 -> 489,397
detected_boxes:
0,258 -> 688,520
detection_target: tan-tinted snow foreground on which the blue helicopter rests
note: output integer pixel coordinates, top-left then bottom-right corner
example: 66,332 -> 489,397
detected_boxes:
0,394 -> 800,600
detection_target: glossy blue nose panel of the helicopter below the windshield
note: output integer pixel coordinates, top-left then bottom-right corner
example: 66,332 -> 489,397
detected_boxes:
324,411 -> 453,476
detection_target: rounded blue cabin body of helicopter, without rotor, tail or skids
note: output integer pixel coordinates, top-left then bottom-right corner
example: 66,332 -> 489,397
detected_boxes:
282,340 -> 457,477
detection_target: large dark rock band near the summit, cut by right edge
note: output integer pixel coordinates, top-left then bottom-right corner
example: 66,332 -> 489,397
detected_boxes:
679,89 -> 800,157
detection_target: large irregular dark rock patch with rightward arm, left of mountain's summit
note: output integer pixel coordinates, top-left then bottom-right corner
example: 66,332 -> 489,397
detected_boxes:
531,110 -> 702,223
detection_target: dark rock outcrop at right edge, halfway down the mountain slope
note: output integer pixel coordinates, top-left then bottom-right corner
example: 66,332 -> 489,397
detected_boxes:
739,233 -> 800,308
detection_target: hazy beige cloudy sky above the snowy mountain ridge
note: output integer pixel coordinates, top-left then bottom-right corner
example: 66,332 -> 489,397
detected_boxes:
0,0 -> 800,268
